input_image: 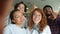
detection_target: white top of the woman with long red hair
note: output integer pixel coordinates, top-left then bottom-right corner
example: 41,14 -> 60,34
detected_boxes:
27,25 -> 51,34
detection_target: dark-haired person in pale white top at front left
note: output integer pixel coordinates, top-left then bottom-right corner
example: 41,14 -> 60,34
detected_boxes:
3,10 -> 26,34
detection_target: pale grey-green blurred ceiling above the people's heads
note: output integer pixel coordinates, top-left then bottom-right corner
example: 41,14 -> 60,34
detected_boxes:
14,0 -> 60,12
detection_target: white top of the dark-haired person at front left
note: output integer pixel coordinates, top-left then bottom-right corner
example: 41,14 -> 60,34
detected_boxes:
3,24 -> 26,34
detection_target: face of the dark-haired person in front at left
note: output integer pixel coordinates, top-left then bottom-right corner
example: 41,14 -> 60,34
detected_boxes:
13,11 -> 25,24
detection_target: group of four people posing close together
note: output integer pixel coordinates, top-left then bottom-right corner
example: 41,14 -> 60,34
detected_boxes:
3,2 -> 60,34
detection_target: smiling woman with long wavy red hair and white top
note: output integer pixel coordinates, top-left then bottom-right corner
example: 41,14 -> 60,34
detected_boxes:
27,8 -> 51,34
